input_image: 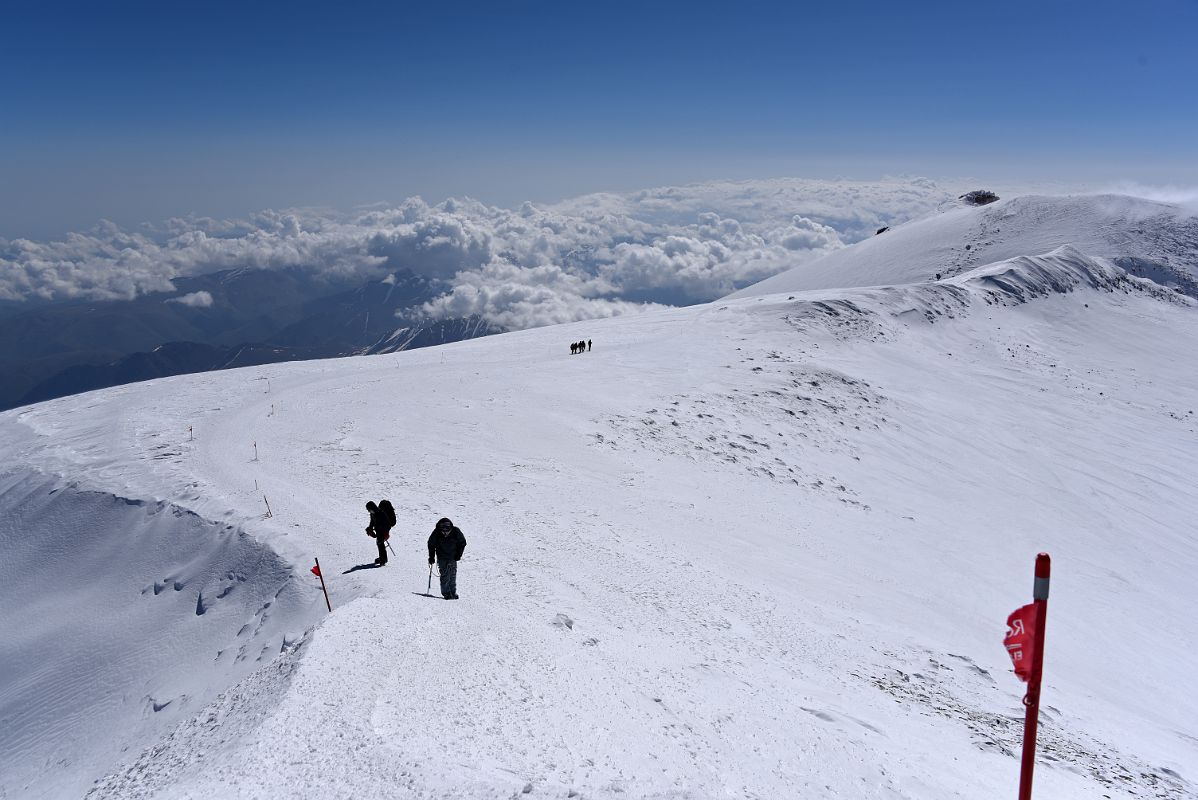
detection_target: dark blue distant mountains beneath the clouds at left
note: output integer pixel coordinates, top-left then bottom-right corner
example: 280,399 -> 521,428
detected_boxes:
0,269 -> 500,410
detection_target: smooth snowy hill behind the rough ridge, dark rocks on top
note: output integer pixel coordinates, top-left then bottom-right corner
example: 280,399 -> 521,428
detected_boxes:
730,195 -> 1198,297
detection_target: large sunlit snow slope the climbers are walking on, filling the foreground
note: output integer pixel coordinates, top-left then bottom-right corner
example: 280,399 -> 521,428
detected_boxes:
0,195 -> 1198,799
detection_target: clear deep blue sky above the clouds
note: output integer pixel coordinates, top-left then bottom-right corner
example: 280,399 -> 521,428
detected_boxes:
0,0 -> 1198,237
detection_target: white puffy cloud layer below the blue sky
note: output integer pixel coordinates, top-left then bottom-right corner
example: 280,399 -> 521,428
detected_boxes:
0,178 -> 949,328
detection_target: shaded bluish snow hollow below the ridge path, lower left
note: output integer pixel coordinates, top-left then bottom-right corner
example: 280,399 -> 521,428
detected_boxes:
0,473 -> 313,798
